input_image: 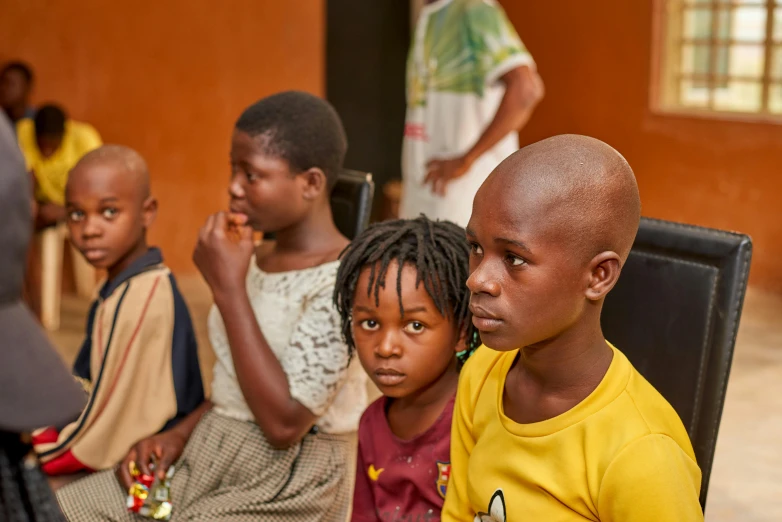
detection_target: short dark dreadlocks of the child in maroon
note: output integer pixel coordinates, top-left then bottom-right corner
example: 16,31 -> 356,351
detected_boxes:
334,215 -> 480,364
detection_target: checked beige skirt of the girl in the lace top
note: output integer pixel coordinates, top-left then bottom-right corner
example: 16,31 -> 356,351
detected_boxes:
57,412 -> 356,522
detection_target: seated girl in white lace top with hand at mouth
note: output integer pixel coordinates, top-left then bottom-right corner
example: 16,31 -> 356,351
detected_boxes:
58,92 -> 366,522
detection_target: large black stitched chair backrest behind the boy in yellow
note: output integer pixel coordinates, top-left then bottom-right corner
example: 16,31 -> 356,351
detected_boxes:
602,218 -> 752,507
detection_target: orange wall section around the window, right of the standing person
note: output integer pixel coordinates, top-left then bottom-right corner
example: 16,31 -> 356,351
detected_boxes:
502,0 -> 782,291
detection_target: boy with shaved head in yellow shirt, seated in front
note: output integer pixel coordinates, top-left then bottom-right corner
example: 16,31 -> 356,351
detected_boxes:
442,136 -> 703,522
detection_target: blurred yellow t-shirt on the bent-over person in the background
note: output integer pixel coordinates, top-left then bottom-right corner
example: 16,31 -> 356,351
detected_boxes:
16,118 -> 102,205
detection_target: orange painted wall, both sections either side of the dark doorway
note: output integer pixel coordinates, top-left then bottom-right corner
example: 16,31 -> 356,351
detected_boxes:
7,0 -> 782,291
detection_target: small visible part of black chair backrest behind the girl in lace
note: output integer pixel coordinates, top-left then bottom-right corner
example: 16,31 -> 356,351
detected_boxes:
331,170 -> 375,240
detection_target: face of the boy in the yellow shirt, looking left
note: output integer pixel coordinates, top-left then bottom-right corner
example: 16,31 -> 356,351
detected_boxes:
467,179 -> 590,350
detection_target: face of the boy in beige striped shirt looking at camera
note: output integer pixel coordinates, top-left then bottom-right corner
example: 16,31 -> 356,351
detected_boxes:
65,162 -> 157,277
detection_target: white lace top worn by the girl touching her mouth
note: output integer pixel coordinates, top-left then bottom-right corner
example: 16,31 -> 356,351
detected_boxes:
208,258 -> 367,434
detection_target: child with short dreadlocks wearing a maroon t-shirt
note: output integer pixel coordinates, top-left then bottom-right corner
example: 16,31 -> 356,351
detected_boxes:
335,216 -> 479,522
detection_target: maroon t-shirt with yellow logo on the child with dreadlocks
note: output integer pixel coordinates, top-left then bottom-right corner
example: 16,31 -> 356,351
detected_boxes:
352,397 -> 453,522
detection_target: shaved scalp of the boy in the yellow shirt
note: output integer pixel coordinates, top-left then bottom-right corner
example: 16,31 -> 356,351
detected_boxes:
480,134 -> 641,262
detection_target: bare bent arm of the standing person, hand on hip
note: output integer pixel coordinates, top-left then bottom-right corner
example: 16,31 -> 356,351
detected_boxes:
424,65 -> 545,195
